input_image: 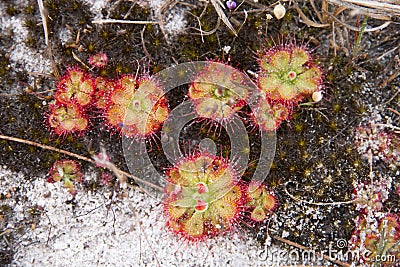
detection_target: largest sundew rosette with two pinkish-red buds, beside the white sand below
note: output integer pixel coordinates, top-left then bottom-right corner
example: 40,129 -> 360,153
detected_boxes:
163,152 -> 243,243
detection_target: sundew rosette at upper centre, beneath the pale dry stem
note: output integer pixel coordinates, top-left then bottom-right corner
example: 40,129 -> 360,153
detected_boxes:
188,62 -> 249,121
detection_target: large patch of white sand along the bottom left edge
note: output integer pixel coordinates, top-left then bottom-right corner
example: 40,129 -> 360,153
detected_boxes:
0,167 -> 288,266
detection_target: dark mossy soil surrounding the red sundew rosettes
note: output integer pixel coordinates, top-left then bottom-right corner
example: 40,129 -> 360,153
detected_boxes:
0,0 -> 400,265
